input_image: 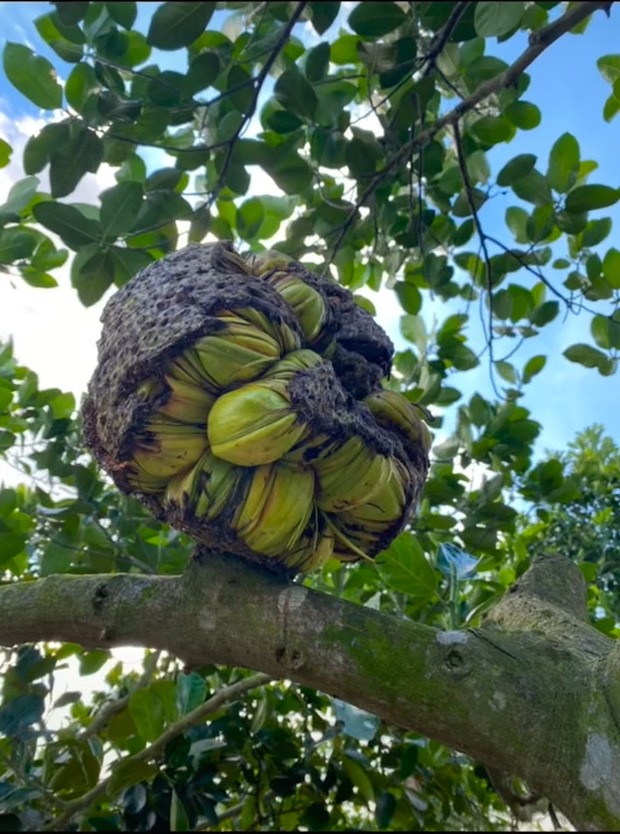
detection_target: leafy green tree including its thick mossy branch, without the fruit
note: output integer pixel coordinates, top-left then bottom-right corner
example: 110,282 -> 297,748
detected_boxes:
0,2 -> 620,830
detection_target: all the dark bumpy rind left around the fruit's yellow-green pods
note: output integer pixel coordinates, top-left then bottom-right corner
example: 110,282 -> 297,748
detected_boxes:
83,237 -> 428,573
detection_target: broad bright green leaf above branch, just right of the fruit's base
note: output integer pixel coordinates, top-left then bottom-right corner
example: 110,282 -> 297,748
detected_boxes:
377,533 -> 437,600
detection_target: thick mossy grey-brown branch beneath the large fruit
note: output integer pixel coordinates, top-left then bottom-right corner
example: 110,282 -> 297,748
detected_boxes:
0,554 -> 620,831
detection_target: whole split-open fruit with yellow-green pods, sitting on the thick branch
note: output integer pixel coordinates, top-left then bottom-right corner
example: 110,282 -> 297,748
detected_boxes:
84,244 -> 429,572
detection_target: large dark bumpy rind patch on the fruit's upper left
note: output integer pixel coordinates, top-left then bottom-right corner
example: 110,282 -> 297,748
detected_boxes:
83,243 -> 299,480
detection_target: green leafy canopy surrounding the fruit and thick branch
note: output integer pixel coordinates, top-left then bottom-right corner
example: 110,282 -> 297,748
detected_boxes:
0,0 -> 620,831
